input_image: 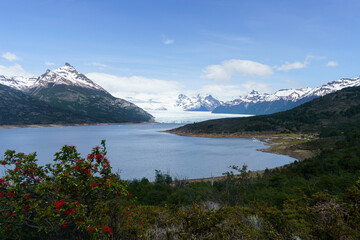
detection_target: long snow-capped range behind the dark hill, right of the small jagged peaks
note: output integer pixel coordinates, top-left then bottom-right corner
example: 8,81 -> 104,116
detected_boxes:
213,77 -> 360,115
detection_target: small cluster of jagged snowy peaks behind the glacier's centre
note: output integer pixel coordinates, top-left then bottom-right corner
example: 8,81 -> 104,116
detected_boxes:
176,94 -> 222,111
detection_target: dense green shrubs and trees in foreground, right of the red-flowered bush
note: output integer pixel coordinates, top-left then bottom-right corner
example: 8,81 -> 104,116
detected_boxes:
124,125 -> 360,239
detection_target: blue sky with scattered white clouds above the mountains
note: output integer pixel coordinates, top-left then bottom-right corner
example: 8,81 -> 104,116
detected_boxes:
0,0 -> 360,99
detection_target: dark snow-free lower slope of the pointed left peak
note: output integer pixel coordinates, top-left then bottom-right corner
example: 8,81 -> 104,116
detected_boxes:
30,84 -> 152,123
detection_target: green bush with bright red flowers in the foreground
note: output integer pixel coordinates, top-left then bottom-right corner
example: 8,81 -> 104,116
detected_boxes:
0,140 -> 139,239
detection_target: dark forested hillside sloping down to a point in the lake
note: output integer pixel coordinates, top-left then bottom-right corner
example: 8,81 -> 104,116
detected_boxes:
170,87 -> 360,135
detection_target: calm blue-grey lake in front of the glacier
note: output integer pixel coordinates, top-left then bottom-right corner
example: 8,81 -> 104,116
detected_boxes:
0,123 -> 294,180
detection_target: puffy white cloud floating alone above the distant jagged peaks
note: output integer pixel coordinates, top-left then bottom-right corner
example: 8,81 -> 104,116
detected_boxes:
201,59 -> 273,82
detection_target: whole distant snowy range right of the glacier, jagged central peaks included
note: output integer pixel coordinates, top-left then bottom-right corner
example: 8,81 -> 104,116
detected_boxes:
176,77 -> 360,115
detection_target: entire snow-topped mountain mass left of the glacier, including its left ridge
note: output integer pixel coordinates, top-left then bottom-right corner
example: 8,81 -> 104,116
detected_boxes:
0,63 -> 154,125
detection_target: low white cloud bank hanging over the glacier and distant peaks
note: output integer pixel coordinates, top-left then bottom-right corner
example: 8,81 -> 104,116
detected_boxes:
86,72 -> 272,111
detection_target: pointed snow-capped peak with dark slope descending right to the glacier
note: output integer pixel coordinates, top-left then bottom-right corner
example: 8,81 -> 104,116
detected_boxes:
26,63 -> 153,123
